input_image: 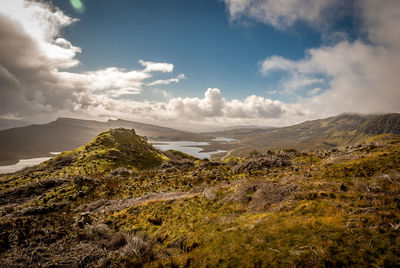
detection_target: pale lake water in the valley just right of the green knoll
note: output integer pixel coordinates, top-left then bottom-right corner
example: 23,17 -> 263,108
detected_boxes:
150,141 -> 226,159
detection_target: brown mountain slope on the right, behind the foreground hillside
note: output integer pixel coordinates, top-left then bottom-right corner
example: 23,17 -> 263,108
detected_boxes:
207,114 -> 400,155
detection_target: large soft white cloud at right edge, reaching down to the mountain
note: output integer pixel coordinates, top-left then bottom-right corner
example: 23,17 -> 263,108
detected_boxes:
260,0 -> 400,117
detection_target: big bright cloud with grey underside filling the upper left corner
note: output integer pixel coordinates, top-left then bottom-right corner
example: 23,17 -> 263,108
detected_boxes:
0,0 -> 181,121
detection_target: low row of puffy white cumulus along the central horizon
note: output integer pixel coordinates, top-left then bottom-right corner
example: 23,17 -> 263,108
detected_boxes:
94,88 -> 292,124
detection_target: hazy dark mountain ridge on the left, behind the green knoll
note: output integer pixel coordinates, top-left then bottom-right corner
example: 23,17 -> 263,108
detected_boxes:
0,118 -> 205,165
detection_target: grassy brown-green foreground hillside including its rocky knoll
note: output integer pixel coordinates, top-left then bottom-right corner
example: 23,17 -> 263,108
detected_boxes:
0,129 -> 400,267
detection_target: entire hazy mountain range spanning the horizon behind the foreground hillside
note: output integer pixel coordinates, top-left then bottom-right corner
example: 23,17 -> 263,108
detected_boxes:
0,114 -> 400,165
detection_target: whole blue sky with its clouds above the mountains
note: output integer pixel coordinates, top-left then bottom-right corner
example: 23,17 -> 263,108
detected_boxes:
0,0 -> 400,131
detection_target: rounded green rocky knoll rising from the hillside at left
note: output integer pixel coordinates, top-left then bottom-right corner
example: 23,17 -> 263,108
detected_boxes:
44,128 -> 167,174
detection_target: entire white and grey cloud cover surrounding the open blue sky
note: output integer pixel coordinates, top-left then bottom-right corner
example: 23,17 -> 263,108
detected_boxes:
0,0 -> 400,130
